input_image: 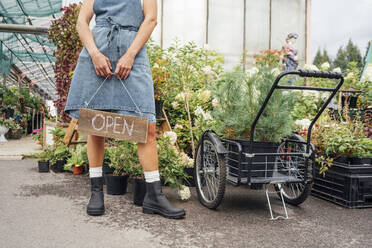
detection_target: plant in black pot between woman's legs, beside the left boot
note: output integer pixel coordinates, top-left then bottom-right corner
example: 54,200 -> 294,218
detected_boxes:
104,141 -> 135,195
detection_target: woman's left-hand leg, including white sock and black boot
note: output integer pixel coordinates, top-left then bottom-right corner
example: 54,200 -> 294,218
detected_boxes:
87,135 -> 105,215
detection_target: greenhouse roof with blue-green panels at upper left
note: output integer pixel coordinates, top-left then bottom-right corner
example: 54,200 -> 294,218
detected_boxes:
0,0 -> 62,99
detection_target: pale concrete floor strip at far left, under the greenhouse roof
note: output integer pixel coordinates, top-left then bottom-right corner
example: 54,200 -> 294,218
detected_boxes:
0,136 -> 41,160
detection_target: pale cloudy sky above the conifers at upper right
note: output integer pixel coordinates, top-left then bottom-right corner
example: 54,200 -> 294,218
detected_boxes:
311,0 -> 372,61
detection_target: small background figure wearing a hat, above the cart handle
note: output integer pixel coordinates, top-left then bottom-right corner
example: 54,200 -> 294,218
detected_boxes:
283,33 -> 298,85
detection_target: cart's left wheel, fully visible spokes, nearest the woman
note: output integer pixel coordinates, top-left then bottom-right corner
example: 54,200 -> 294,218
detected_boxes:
195,135 -> 226,209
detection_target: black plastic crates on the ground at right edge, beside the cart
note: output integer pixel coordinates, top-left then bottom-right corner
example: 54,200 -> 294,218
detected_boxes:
312,163 -> 372,208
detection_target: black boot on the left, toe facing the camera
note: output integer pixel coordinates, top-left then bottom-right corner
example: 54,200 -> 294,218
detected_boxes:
87,177 -> 105,216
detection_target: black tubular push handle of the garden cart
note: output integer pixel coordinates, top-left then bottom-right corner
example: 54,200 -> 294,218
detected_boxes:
249,70 -> 344,154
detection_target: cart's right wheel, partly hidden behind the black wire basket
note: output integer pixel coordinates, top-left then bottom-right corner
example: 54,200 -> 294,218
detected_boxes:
275,134 -> 313,206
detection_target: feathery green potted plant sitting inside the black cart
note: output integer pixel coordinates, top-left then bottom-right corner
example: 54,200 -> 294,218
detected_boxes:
212,66 -> 294,177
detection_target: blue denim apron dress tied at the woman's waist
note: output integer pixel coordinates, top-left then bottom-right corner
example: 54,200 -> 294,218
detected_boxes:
64,0 -> 156,123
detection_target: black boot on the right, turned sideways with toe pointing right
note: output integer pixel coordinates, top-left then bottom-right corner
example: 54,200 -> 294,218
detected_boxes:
142,181 -> 186,219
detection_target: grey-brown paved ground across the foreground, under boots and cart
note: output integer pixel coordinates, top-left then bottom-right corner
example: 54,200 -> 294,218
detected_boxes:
0,159 -> 372,248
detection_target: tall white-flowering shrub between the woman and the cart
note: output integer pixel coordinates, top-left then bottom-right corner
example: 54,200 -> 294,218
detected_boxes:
148,40 -> 223,155
